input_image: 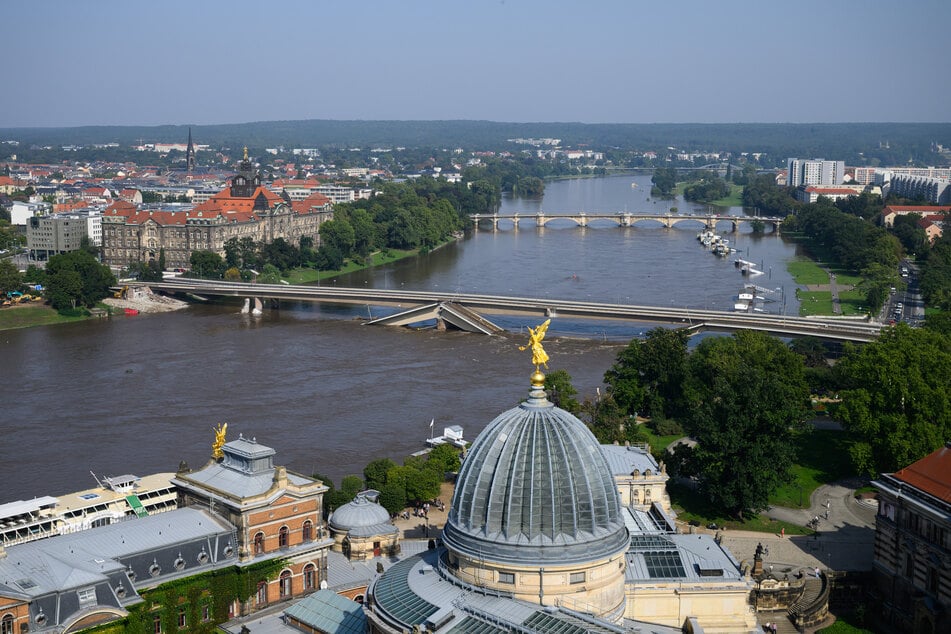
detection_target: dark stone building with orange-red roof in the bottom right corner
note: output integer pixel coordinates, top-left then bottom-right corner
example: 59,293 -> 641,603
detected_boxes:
872,443 -> 951,634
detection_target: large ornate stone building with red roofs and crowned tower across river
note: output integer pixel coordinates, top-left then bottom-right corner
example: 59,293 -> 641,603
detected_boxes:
102,150 -> 333,268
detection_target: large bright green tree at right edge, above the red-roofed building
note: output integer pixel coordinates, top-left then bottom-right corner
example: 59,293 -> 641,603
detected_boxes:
833,324 -> 951,475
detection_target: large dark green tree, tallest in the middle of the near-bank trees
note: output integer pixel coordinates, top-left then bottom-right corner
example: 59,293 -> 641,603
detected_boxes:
684,331 -> 809,518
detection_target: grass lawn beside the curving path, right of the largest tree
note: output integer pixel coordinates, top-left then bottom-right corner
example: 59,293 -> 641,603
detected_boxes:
769,429 -> 854,508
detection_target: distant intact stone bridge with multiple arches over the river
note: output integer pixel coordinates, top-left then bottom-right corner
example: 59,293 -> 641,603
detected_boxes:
469,211 -> 783,234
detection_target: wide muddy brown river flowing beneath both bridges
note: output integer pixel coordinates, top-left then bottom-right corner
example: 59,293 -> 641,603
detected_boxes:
0,176 -> 796,503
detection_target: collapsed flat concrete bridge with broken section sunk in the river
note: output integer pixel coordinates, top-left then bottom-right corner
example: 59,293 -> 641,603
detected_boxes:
150,278 -> 882,342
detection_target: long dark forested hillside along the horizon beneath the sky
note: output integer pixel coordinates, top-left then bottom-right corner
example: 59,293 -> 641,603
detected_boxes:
0,120 -> 951,166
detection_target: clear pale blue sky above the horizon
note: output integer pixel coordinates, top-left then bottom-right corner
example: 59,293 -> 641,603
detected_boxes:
7,0 -> 951,128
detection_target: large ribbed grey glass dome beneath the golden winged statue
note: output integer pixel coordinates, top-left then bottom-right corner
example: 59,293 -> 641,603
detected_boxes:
443,383 -> 628,563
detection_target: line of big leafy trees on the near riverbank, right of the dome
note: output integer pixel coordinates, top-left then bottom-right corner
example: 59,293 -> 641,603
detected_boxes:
564,324 -> 951,518
